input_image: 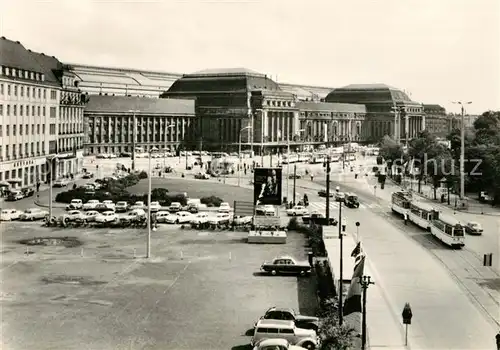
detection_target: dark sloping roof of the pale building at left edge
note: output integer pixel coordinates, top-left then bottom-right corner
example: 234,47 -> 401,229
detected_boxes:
0,36 -> 43,73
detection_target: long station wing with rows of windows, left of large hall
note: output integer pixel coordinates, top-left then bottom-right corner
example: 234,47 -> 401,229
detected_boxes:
84,95 -> 195,154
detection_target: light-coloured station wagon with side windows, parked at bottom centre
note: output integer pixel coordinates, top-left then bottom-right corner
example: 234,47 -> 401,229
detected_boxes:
250,319 -> 320,349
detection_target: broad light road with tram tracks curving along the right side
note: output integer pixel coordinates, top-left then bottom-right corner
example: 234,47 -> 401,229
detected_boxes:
297,179 -> 499,349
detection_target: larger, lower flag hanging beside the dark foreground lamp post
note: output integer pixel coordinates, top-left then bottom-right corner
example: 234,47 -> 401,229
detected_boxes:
343,255 -> 365,333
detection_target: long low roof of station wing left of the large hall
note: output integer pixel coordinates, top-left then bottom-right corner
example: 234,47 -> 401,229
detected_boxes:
85,95 -> 195,115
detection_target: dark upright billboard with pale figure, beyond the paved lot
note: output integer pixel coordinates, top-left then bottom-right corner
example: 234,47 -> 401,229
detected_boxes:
253,168 -> 282,205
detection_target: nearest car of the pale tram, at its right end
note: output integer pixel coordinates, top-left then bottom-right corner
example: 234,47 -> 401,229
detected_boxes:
430,211 -> 465,249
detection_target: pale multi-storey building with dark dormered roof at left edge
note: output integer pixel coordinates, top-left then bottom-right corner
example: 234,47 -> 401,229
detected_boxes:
0,37 -> 83,187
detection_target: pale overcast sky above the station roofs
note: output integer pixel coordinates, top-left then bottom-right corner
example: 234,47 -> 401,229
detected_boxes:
0,0 -> 500,113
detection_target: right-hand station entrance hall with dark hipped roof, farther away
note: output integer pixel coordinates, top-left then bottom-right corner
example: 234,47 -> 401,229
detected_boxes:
325,84 -> 426,141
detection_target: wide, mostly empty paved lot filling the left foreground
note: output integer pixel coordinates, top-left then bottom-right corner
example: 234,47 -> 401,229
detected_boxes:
1,222 -> 316,349
